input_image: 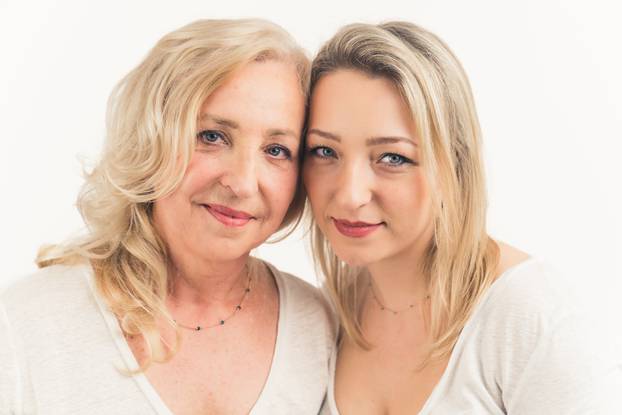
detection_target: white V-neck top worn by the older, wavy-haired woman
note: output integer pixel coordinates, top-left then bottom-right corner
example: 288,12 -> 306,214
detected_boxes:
0,265 -> 334,415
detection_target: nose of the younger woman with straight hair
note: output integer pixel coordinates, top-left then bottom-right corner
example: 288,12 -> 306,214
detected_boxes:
334,164 -> 373,211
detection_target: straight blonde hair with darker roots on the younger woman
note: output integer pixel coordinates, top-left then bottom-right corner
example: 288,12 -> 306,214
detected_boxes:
310,22 -> 499,365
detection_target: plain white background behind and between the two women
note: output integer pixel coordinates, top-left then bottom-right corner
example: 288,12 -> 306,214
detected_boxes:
0,0 -> 622,316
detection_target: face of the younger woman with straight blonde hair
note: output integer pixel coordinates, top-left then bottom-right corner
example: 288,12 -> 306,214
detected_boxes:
303,69 -> 433,266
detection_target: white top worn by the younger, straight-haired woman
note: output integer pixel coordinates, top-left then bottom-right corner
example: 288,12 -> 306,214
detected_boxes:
321,259 -> 622,415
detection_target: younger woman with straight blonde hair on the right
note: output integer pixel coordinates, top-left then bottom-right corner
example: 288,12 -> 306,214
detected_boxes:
304,22 -> 622,415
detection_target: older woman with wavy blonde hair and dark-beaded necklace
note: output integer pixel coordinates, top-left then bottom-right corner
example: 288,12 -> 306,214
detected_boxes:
0,20 -> 334,414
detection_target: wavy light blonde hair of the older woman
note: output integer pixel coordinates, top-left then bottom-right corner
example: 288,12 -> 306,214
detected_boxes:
36,19 -> 310,369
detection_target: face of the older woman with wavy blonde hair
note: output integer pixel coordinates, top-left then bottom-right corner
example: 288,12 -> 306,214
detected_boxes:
154,61 -> 304,261
